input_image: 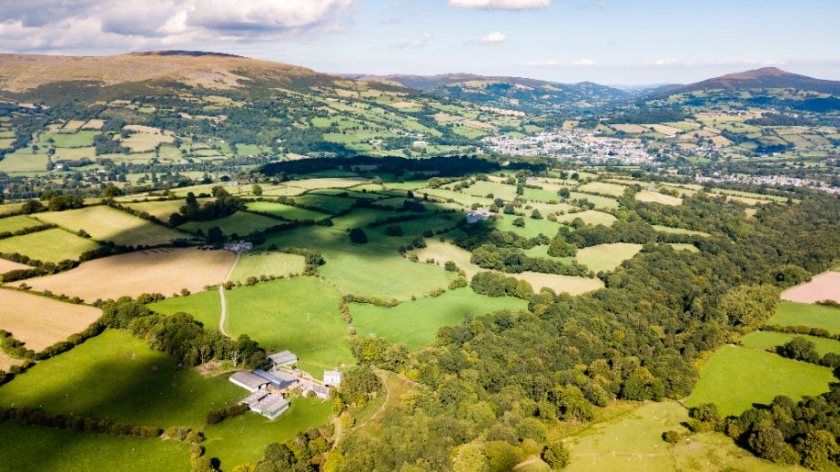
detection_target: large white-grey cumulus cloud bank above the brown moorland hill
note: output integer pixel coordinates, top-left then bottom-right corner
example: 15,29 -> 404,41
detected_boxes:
0,0 -> 353,50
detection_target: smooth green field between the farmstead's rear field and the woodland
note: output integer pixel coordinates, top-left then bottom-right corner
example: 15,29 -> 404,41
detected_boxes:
350,288 -> 528,351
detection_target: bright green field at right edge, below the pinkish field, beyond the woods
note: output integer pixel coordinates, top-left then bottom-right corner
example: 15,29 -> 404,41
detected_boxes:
686,346 -> 836,415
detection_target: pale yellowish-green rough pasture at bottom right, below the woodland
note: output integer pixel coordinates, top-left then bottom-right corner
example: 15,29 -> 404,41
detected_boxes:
560,401 -> 801,472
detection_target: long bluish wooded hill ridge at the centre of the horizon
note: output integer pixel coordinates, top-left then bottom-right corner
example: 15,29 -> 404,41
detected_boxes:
348,74 -> 632,113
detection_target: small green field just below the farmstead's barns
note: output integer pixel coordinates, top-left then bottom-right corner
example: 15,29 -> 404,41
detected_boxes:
202,398 -> 332,471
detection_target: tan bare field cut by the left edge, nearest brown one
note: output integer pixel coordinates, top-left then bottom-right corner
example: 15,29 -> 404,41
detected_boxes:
0,289 -> 102,352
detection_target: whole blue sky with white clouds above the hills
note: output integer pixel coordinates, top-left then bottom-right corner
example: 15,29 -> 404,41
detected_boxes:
0,0 -> 840,85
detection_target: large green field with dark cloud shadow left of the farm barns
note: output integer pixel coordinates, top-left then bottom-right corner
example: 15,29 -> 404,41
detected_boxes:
0,330 -> 243,427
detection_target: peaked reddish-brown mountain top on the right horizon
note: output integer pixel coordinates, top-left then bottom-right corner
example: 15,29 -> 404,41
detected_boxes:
672,67 -> 840,95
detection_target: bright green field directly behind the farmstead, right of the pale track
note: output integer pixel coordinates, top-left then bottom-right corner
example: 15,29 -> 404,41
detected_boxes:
225,277 -> 354,375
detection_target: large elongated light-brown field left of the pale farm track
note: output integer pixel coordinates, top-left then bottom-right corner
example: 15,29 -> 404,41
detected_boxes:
17,248 -> 236,302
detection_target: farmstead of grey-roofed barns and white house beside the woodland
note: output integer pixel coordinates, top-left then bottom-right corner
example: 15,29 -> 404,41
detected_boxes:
228,351 -> 341,420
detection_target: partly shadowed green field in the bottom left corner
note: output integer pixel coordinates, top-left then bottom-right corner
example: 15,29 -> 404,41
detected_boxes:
0,422 -> 190,472
